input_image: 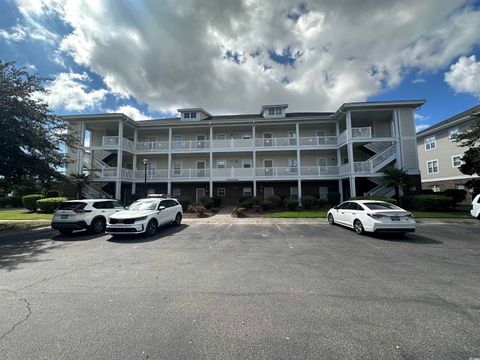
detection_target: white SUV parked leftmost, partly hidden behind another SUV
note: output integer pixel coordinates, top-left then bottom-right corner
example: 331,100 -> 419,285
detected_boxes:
52,199 -> 125,234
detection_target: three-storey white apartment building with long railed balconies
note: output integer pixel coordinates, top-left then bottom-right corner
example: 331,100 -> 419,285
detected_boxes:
63,100 -> 424,205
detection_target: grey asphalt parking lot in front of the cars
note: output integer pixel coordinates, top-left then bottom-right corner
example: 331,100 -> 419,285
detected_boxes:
0,221 -> 480,359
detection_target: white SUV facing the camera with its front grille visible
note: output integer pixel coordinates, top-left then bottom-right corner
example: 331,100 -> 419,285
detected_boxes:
107,197 -> 183,236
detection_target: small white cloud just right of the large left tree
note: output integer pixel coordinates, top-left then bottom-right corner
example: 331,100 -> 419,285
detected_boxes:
39,71 -> 108,111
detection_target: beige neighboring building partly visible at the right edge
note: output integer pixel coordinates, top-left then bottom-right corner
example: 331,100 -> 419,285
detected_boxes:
417,105 -> 480,200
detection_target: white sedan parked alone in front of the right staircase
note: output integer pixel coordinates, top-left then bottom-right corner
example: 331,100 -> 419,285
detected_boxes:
327,200 -> 416,235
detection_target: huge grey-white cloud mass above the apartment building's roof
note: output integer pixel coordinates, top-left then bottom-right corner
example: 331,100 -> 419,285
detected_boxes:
8,0 -> 480,113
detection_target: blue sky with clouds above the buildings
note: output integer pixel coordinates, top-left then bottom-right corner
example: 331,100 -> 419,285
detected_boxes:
0,0 -> 480,130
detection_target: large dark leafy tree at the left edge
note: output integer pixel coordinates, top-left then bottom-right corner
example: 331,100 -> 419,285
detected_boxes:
0,60 -> 76,192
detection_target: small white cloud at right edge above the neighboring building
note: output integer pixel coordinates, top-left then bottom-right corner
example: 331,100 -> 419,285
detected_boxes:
444,55 -> 480,98
